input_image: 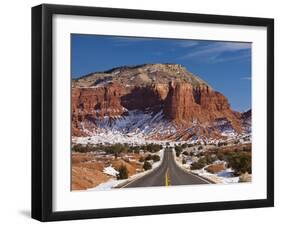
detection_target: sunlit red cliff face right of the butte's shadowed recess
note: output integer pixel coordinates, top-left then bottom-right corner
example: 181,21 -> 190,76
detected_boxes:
164,82 -> 241,132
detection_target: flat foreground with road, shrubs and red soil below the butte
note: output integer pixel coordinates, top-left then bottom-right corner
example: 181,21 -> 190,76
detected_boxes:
72,142 -> 251,190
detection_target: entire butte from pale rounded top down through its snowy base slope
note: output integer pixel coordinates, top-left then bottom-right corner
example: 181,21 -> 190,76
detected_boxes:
72,64 -> 249,140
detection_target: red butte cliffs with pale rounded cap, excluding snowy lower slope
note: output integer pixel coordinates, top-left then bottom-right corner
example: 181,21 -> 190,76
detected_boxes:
72,64 -> 248,139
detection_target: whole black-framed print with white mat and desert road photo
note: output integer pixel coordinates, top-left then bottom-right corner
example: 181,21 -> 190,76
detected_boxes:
32,4 -> 274,221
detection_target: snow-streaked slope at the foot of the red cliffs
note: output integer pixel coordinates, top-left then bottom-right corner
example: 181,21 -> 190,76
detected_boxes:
72,108 -> 251,144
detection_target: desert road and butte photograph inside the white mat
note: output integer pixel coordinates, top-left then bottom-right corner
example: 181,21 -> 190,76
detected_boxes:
71,33 -> 252,191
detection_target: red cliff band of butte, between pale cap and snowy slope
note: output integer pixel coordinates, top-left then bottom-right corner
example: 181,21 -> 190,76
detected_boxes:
72,62 -> 241,139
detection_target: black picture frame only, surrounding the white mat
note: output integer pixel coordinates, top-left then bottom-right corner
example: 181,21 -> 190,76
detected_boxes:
32,4 -> 274,221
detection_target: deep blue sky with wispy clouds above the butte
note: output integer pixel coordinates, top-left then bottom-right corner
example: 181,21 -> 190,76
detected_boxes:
71,34 -> 252,111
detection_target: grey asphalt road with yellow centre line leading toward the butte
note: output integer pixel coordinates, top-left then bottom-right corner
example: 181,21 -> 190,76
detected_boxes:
123,150 -> 208,188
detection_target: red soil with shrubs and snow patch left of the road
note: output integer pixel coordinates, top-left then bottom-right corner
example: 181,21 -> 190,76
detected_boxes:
72,143 -> 163,190
